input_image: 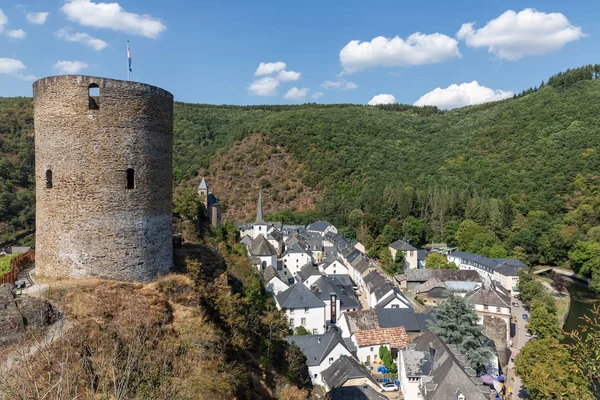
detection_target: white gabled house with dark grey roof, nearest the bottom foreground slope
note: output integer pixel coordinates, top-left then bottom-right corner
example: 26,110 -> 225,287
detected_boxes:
285,330 -> 353,386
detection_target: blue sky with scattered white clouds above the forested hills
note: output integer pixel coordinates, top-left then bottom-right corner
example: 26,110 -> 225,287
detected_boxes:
0,0 -> 600,108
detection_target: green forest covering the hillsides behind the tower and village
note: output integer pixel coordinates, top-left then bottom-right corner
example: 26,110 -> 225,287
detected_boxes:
0,65 -> 600,289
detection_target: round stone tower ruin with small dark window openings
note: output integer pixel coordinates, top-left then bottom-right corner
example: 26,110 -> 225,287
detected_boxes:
33,75 -> 173,281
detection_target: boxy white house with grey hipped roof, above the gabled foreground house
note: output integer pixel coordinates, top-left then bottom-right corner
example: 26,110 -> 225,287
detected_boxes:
275,283 -> 326,335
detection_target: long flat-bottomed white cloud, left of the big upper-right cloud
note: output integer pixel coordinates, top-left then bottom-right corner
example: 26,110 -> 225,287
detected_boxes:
340,32 -> 461,72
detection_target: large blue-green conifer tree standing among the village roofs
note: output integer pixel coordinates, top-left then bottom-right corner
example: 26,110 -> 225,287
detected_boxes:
431,296 -> 492,373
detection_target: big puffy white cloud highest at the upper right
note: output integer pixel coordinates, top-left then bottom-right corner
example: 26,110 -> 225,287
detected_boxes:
456,8 -> 586,60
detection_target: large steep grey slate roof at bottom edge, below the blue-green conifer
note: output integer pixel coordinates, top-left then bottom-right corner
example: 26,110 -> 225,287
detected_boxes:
404,332 -> 489,400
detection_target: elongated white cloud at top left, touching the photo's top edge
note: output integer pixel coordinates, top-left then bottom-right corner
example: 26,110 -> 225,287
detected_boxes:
61,0 -> 167,39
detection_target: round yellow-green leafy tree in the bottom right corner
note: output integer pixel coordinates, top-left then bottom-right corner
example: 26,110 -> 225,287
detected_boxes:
515,338 -> 594,400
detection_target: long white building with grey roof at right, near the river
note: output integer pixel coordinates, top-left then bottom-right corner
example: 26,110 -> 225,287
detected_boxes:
446,251 -> 526,294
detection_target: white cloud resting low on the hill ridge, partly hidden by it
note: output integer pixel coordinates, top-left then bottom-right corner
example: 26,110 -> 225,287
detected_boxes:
415,81 -> 514,109
